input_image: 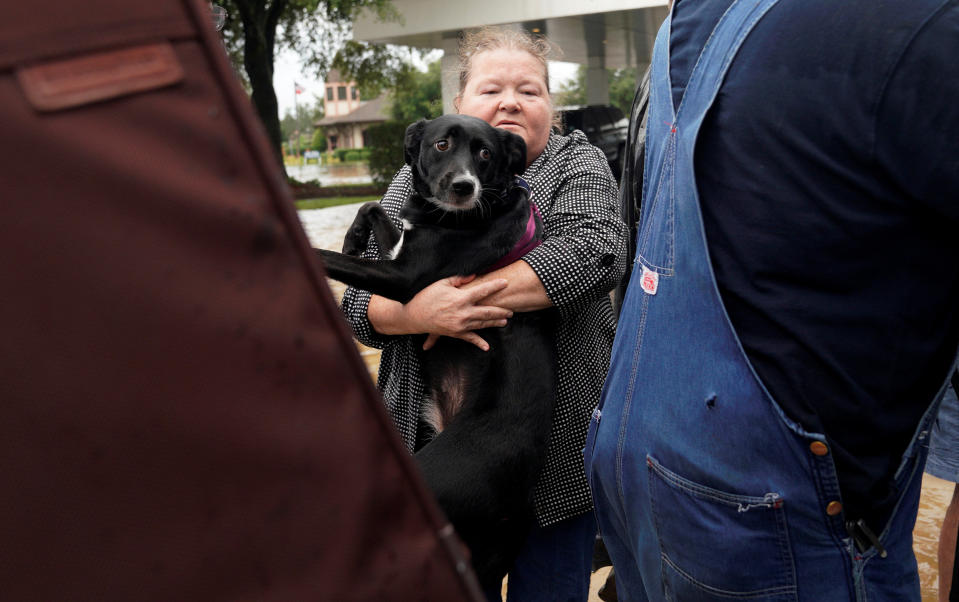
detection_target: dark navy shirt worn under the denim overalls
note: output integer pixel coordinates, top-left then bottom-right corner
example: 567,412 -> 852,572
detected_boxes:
670,0 -> 959,533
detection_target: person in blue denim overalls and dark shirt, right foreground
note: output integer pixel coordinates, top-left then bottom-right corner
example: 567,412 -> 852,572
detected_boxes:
584,0 -> 959,602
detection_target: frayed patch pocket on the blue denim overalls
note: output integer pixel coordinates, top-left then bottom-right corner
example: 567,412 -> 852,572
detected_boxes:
646,456 -> 798,602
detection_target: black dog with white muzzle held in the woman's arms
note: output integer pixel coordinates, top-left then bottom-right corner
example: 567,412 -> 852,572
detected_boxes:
318,115 -> 555,588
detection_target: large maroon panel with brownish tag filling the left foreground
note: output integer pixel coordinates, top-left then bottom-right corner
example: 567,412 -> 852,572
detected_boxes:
0,0 -> 478,602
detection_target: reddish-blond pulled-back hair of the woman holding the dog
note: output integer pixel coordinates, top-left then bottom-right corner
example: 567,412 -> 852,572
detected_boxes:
456,27 -> 559,126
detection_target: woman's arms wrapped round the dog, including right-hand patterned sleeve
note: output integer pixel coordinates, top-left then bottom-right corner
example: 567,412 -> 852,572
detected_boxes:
351,132 -> 627,350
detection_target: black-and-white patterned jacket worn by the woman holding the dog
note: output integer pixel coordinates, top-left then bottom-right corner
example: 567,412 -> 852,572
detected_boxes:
343,131 -> 628,526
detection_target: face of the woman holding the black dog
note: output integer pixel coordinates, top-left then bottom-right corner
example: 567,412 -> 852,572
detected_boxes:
457,48 -> 553,165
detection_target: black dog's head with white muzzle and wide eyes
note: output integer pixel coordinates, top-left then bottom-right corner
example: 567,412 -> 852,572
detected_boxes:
405,115 -> 526,211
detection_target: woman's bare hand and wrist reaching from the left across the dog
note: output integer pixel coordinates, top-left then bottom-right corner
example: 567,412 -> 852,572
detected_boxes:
367,276 -> 513,351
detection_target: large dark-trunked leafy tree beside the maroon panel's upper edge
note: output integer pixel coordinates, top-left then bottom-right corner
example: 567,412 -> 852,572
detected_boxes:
217,0 -> 398,170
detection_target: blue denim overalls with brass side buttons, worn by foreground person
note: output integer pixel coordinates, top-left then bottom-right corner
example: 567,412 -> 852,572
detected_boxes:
585,0 -> 945,602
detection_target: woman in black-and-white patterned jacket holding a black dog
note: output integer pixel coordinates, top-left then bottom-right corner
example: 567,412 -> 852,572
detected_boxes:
343,28 -> 627,602
